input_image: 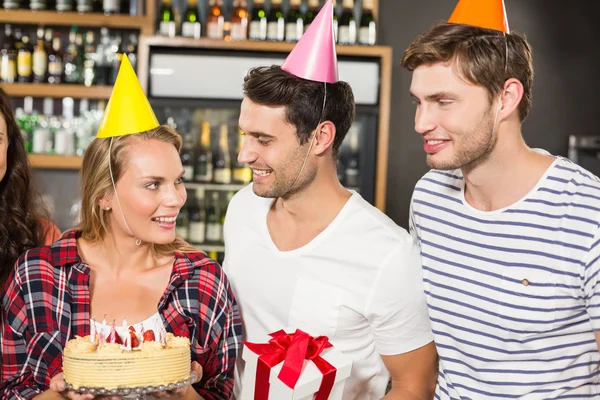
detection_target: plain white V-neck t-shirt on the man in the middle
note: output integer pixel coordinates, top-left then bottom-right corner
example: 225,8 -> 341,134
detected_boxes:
224,185 -> 433,400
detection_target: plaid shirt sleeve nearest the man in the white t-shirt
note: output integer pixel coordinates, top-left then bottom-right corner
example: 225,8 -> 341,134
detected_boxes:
194,260 -> 242,400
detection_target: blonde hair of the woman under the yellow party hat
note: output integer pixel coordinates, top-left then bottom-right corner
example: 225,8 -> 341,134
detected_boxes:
75,125 -> 196,255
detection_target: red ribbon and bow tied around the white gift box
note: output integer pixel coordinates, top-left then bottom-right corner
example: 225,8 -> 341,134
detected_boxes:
244,329 -> 337,400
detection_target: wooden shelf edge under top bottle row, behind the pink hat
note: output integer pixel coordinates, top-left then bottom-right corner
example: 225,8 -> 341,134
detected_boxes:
140,36 -> 389,57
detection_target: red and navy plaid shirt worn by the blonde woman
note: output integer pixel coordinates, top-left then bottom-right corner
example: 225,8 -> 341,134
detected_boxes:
0,231 -> 242,400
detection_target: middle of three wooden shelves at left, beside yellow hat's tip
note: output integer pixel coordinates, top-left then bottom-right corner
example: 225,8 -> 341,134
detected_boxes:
0,83 -> 112,99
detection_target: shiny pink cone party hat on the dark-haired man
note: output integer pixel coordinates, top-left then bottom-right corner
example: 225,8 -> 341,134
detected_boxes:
281,0 -> 339,83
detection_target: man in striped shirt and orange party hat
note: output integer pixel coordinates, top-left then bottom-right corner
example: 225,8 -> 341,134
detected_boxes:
402,0 -> 600,400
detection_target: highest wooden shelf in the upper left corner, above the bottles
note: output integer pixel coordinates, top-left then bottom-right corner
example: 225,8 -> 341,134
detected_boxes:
0,10 -> 152,32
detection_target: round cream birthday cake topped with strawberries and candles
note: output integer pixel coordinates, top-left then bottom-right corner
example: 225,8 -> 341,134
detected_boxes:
63,327 -> 190,392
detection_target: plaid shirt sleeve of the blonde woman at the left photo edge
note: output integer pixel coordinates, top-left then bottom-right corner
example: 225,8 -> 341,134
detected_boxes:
0,248 -> 62,399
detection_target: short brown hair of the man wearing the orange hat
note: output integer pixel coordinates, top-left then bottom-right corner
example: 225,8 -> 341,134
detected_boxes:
402,22 -> 533,122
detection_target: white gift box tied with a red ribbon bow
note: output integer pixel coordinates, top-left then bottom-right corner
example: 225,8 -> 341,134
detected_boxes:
240,330 -> 352,400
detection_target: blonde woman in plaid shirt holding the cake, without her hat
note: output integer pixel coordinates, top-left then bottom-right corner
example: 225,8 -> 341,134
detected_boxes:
0,126 -> 242,399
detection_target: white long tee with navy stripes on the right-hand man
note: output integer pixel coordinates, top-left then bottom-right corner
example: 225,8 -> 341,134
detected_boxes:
410,157 -> 600,400
